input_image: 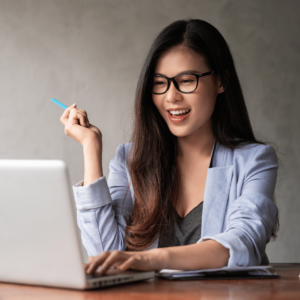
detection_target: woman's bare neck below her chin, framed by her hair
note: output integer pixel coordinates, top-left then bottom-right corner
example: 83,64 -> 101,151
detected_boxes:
177,124 -> 215,161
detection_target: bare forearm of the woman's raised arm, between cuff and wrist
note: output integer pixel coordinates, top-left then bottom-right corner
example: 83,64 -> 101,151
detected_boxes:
83,138 -> 103,185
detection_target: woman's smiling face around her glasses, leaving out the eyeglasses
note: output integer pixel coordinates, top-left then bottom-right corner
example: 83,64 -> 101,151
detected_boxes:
152,47 -> 224,137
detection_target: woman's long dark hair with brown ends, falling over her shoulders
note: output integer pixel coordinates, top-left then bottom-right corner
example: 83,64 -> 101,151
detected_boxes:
125,19 -> 278,250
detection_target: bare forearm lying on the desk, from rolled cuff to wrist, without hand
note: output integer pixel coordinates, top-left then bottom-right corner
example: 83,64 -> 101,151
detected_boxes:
156,240 -> 229,270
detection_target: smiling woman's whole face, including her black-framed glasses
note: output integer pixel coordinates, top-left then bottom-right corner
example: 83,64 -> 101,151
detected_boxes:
152,49 -> 224,137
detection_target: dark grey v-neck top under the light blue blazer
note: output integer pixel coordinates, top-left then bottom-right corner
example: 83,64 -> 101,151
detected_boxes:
158,141 -> 216,248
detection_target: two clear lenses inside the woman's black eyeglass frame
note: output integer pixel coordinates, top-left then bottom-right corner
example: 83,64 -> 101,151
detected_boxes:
152,74 -> 197,94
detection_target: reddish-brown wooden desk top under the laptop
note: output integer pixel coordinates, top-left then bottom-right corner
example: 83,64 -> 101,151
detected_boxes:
0,264 -> 300,300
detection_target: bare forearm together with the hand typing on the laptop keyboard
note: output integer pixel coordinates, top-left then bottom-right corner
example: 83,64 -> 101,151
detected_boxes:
86,240 -> 229,274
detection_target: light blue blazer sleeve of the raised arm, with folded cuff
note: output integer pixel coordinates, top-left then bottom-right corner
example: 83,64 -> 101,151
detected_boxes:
73,144 -> 132,256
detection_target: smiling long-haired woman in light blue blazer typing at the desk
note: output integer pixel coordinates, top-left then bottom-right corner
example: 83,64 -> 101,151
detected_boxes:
61,20 -> 278,274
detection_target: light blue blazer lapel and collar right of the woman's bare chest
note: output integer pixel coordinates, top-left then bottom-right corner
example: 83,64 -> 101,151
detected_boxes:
201,143 -> 233,237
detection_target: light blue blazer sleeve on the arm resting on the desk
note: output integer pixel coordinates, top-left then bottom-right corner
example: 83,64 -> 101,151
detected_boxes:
199,145 -> 278,267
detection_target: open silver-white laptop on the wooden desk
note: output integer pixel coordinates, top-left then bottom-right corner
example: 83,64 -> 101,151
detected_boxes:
0,159 -> 154,289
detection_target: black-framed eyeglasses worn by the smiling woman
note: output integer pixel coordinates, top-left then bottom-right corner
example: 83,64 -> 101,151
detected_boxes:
151,71 -> 214,95
